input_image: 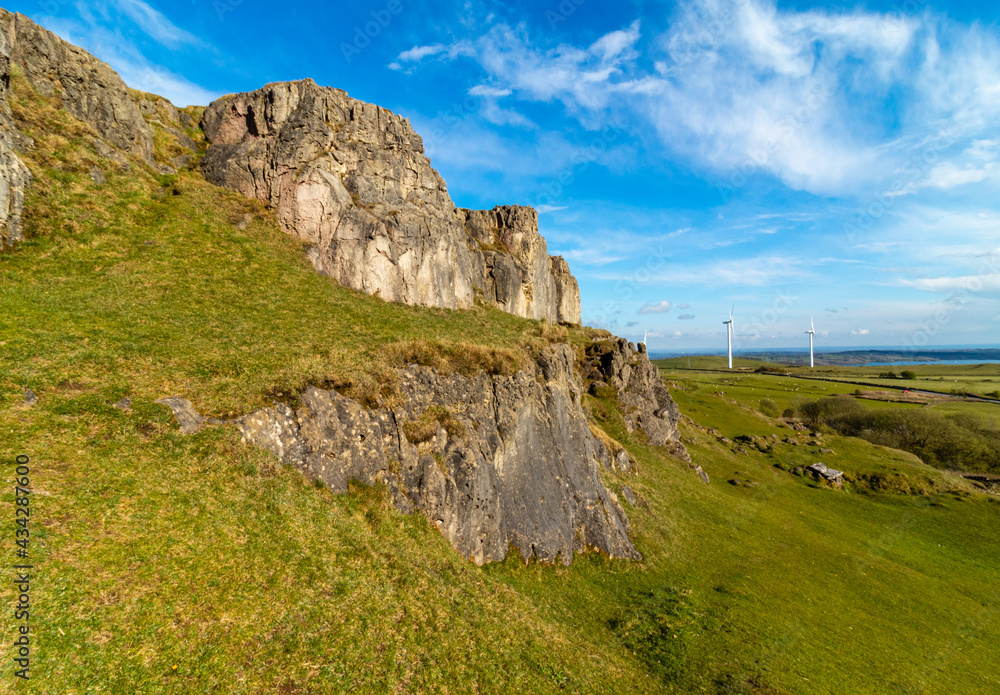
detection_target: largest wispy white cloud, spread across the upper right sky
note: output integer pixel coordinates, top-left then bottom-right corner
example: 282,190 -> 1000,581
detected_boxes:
401,0 -> 1000,197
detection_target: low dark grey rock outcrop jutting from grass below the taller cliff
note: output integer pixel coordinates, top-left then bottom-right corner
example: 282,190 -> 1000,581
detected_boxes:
238,345 -> 640,564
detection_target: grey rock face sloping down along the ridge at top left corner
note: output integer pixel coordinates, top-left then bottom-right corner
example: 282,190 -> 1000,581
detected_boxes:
0,10 -> 153,161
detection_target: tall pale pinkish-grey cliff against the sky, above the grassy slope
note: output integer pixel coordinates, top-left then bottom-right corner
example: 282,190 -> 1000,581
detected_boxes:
202,80 -> 580,323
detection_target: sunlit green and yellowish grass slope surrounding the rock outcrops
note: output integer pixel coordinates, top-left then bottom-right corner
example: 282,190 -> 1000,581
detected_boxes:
0,73 -> 1000,695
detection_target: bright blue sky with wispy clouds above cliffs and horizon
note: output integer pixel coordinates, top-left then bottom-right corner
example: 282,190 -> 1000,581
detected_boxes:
13,0 -> 1000,350
